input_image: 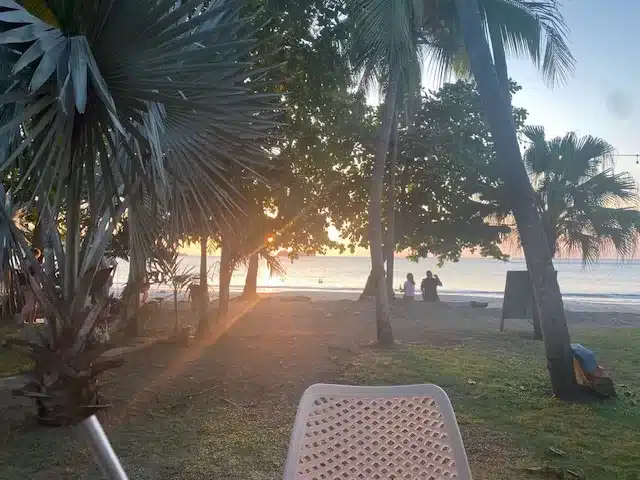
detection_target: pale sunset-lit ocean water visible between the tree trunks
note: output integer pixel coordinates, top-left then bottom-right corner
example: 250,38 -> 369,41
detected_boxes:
114,255 -> 640,311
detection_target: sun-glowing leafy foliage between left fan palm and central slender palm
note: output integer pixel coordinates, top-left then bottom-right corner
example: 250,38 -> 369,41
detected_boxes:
234,0 -> 352,257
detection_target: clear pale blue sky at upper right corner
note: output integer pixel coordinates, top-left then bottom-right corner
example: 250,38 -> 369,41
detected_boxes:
509,0 -> 640,180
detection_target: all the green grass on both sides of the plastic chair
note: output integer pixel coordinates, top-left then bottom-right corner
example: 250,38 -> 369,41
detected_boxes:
0,329 -> 640,480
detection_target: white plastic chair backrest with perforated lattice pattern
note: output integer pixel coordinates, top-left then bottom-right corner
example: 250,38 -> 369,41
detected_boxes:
284,384 -> 471,480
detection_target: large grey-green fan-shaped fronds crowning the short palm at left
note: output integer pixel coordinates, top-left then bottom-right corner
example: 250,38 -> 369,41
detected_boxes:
0,0 -> 275,223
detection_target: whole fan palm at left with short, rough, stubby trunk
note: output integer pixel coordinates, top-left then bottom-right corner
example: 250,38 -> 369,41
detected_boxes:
0,0 -> 274,424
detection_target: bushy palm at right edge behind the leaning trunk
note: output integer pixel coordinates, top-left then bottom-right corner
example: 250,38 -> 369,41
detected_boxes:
523,126 -> 640,263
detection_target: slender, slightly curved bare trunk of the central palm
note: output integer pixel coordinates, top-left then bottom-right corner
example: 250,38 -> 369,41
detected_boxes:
369,65 -> 401,345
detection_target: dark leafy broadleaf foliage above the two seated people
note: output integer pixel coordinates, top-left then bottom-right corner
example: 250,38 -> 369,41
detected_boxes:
332,81 -> 526,262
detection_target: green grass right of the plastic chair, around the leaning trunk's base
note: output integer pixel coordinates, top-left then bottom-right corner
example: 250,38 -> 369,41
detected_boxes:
346,329 -> 640,480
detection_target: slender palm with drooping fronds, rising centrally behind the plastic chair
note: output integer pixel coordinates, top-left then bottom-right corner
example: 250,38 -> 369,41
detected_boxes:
350,0 -> 432,345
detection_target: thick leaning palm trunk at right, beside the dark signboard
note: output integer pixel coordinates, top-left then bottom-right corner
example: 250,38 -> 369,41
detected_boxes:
456,0 -> 576,398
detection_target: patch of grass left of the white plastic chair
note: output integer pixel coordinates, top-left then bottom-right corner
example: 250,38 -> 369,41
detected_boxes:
0,402 -> 293,480
